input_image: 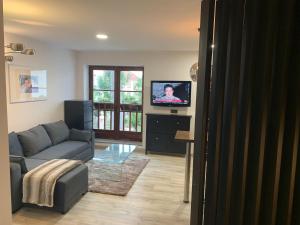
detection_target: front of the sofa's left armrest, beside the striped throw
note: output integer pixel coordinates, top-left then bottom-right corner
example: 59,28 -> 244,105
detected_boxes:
10,162 -> 22,212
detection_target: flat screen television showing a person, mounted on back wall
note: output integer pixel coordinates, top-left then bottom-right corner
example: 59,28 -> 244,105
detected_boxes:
151,80 -> 192,107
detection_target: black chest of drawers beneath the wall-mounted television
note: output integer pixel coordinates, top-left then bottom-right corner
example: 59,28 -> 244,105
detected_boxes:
146,113 -> 192,155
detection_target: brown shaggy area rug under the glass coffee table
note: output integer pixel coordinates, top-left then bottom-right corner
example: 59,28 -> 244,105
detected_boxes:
86,150 -> 150,196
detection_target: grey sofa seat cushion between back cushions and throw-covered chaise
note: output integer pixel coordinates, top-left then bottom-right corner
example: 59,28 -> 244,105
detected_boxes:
30,141 -> 90,160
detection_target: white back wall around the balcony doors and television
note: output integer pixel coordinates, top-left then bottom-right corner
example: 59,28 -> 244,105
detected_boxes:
76,51 -> 198,144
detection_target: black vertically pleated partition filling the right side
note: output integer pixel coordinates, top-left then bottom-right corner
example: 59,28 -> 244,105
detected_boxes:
191,0 -> 300,225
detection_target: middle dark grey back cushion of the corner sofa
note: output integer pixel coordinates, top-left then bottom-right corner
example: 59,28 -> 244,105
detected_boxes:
18,126 -> 52,156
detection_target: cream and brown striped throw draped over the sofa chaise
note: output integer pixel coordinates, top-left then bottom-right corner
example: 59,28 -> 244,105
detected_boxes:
23,159 -> 82,207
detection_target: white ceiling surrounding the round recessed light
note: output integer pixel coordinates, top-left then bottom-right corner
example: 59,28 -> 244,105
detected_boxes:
4,0 -> 200,50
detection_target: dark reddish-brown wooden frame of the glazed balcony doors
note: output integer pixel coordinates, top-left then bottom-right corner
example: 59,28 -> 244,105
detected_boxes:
89,65 -> 145,142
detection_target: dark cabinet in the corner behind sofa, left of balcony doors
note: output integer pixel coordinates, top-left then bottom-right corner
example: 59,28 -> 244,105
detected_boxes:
65,100 -> 93,130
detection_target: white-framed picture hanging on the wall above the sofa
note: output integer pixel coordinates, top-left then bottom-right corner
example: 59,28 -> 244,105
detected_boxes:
8,65 -> 47,103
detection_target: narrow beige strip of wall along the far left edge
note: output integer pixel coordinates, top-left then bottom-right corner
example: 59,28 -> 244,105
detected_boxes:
0,0 -> 12,225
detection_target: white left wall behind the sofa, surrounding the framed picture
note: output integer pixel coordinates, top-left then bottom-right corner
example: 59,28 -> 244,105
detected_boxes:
4,33 -> 76,131
